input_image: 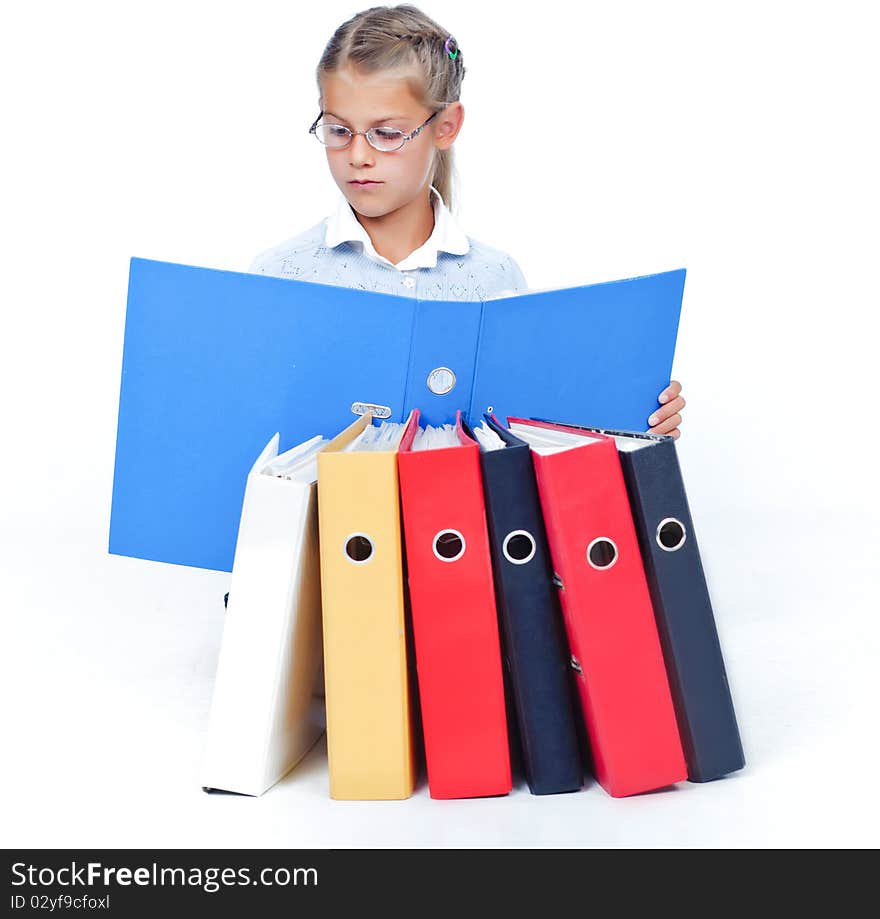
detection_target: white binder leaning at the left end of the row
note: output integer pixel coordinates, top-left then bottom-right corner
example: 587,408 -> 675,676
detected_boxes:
202,434 -> 327,795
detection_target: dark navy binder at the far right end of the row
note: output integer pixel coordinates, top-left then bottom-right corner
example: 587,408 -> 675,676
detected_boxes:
540,425 -> 745,782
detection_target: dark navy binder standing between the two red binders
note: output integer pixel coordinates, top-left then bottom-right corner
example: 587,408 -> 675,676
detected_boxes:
463,415 -> 583,795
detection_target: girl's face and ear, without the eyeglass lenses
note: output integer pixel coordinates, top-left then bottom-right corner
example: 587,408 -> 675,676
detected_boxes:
321,68 -> 464,217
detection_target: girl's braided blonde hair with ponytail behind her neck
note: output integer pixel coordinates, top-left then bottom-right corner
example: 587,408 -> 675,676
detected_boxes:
316,3 -> 465,209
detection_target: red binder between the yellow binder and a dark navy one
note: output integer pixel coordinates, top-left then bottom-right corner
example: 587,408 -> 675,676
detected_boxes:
398,410 -> 511,798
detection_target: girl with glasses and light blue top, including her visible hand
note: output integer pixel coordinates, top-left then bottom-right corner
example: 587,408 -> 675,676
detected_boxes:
250,4 -> 684,438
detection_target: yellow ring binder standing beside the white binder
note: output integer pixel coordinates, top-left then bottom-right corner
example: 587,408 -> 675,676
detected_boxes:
318,415 -> 415,800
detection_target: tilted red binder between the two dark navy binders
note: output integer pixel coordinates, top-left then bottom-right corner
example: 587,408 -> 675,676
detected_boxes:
508,418 -> 687,797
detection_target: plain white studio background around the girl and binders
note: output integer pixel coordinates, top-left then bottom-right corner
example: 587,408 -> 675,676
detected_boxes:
0,0 -> 880,847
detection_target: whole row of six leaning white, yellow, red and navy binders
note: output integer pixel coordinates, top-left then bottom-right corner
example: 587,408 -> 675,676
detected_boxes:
203,409 -> 744,800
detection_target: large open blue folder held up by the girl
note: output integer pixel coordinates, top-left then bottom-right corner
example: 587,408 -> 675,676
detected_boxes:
110,258 -> 685,571
